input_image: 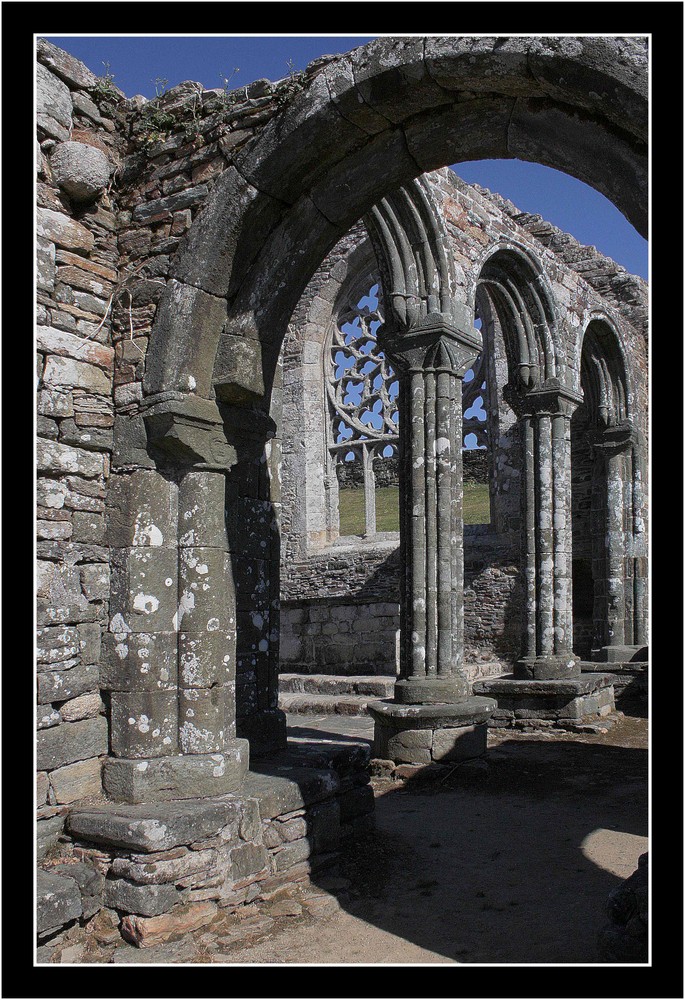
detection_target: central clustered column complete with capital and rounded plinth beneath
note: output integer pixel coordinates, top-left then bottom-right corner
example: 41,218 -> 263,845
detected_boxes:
370,314 -> 494,763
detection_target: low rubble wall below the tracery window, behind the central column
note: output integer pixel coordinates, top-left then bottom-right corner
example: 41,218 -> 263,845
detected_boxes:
280,525 -> 524,680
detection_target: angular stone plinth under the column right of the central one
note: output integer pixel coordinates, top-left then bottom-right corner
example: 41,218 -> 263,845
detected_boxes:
473,673 -> 615,728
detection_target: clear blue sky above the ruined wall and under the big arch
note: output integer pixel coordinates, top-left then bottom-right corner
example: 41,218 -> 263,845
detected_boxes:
42,34 -> 647,278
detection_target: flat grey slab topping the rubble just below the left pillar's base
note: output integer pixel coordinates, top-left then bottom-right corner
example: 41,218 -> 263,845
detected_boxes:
68,795 -> 240,854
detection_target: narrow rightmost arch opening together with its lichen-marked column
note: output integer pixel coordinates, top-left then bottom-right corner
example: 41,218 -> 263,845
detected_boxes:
571,315 -> 646,660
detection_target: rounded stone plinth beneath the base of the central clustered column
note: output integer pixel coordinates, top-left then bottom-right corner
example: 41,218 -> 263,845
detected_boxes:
367,697 -> 496,764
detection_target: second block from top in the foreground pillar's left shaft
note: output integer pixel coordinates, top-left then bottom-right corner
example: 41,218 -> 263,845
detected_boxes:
110,548 -> 176,633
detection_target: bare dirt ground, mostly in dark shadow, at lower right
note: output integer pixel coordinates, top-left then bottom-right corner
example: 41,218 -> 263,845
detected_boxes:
218,716 -> 648,964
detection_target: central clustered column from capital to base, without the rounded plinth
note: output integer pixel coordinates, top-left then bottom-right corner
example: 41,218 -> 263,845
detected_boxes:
389,325 -> 479,704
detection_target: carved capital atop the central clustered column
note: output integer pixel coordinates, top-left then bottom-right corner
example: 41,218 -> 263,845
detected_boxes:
380,313 -> 483,377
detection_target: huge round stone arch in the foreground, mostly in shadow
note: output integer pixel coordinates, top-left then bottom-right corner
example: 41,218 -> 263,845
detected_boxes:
144,38 -> 647,414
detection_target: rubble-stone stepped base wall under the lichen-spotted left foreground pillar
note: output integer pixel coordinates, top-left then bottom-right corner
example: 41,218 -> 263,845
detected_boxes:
38,746 -> 374,958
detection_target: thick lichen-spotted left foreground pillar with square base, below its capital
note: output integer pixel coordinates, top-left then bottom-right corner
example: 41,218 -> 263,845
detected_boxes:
101,470 -> 248,802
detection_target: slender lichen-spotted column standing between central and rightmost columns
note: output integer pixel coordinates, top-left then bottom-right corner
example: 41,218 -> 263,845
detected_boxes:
514,379 -> 581,680
